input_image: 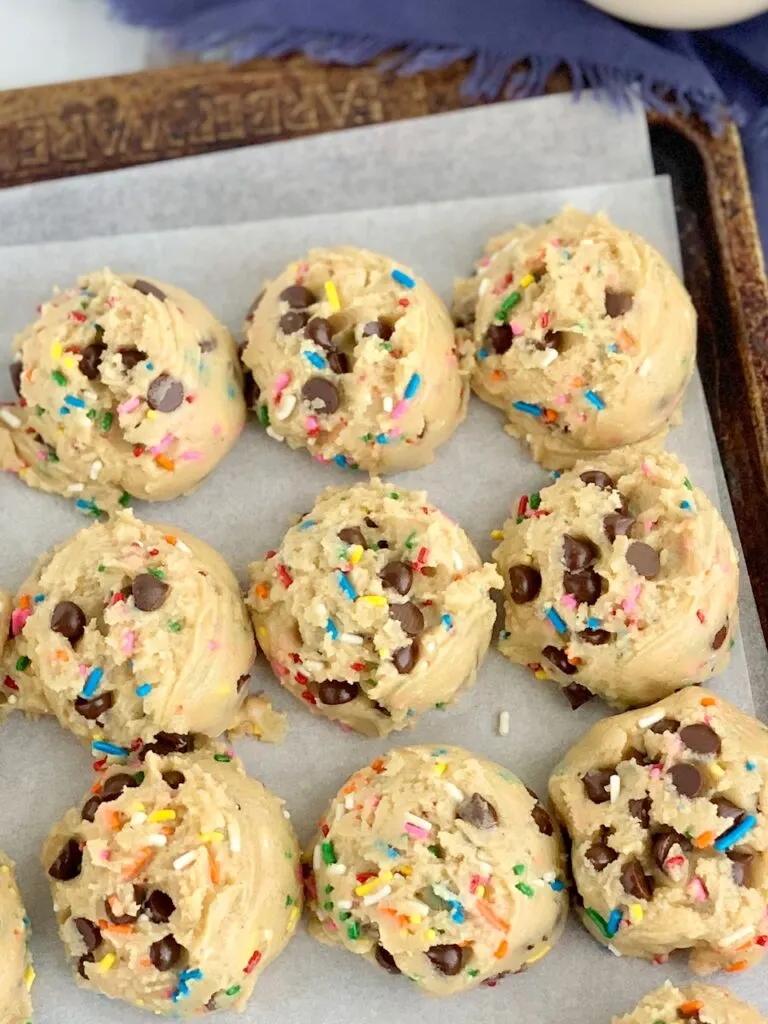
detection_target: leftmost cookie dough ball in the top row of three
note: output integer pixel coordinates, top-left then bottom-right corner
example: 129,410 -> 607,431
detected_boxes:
0,270 -> 246,515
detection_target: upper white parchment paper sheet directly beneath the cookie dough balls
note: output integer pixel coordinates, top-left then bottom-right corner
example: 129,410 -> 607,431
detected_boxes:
0,179 -> 768,1024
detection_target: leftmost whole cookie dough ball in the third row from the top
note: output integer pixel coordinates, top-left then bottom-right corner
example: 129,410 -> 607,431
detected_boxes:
43,750 -> 302,1017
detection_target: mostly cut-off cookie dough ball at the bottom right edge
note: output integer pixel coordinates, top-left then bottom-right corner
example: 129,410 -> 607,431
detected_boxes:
612,981 -> 766,1024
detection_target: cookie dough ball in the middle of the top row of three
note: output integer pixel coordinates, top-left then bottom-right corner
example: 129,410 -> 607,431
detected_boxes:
243,246 -> 469,473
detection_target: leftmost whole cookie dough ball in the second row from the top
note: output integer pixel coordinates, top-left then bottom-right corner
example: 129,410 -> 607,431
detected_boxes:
0,511 -> 260,757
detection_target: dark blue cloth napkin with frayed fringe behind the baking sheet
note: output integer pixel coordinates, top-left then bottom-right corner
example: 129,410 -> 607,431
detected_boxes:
109,0 -> 768,251
